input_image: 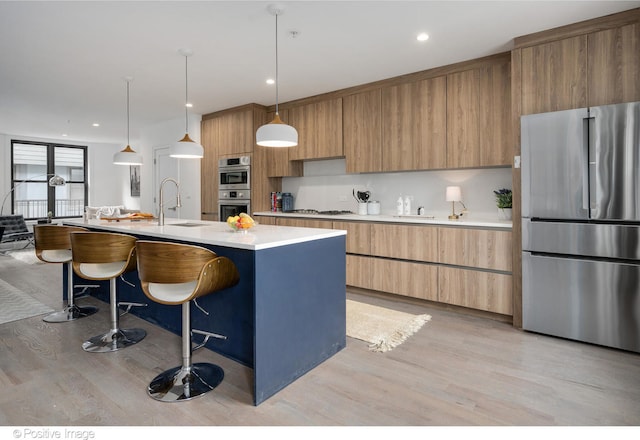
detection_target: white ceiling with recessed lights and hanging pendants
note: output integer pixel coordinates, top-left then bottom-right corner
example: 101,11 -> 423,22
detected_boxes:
0,1 -> 640,144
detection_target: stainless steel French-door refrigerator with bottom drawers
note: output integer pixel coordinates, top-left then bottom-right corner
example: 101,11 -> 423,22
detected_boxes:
521,102 -> 640,352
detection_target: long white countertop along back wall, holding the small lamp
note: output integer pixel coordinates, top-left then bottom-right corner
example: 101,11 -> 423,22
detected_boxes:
253,211 -> 512,229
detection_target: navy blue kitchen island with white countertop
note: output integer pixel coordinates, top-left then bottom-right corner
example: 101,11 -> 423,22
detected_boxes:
63,219 -> 346,405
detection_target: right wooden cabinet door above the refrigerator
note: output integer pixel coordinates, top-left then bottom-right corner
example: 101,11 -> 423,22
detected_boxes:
587,23 -> 640,106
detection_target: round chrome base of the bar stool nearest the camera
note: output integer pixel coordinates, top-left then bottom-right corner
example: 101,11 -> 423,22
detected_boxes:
147,362 -> 224,402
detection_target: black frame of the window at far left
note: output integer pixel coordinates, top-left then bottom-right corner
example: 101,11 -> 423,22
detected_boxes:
10,139 -> 89,220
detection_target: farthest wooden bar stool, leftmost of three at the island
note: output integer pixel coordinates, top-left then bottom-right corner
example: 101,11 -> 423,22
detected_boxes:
33,225 -> 98,322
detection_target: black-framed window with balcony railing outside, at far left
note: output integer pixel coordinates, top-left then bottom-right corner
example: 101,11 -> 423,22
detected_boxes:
2,140 -> 88,219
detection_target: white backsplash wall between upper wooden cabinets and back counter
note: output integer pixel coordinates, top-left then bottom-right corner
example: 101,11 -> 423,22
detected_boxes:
282,159 -> 511,219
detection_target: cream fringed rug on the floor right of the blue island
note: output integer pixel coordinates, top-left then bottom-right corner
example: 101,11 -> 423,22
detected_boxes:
347,300 -> 431,352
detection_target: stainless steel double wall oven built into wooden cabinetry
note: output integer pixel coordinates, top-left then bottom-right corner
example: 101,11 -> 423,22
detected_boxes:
218,156 -> 251,221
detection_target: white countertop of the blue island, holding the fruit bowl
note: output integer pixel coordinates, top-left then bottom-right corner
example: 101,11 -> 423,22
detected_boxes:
62,219 -> 346,250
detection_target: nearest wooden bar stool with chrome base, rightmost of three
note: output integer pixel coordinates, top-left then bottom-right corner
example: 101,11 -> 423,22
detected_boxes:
136,240 -> 240,402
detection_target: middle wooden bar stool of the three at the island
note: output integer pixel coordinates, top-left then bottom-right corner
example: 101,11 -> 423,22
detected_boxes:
71,232 -> 147,353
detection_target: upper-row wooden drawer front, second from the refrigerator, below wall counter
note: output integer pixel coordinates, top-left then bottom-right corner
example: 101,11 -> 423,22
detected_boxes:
371,223 -> 438,262
